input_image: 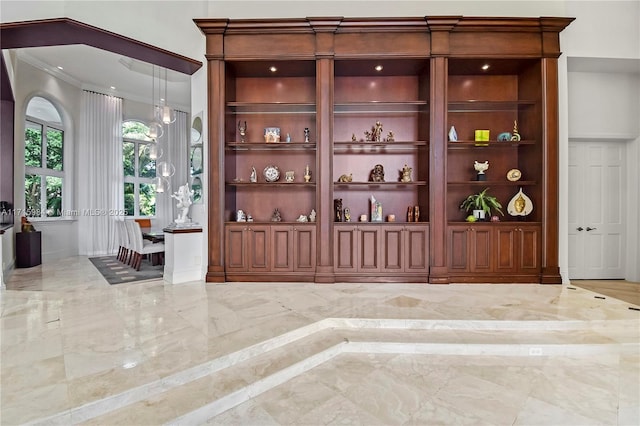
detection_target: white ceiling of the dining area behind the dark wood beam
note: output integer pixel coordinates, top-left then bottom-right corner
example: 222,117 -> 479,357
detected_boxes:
14,44 -> 191,111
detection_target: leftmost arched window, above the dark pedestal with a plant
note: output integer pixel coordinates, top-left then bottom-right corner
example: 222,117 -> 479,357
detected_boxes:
24,96 -> 65,218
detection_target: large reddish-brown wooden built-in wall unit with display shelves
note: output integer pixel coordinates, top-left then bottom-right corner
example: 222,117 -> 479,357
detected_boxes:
195,16 -> 572,284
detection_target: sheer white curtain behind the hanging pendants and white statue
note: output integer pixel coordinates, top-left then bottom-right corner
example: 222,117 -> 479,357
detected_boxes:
154,111 -> 191,227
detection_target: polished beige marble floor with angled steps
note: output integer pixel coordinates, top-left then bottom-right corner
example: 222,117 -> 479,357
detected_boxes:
0,257 -> 640,425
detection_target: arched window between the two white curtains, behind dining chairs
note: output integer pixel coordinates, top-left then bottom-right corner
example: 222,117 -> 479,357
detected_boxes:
122,121 -> 159,217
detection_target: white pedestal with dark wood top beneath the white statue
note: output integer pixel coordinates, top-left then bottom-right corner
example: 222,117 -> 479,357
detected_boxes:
163,228 -> 202,284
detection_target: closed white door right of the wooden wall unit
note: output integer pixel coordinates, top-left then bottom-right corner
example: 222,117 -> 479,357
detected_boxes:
569,142 -> 626,279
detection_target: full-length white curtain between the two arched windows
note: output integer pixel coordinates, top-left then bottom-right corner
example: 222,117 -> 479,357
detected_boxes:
76,91 -> 124,256
